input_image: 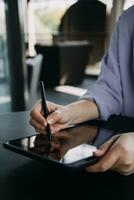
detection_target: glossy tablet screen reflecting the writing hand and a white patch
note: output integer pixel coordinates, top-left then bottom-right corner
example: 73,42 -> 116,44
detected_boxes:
6,125 -> 113,164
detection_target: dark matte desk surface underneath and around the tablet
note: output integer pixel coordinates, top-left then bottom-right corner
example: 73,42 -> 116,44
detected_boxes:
0,112 -> 134,200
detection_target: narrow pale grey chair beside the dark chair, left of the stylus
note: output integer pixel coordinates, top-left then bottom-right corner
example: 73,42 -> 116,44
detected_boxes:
26,54 -> 43,107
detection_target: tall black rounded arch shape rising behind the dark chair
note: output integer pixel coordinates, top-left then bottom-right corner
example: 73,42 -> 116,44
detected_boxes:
55,0 -> 106,63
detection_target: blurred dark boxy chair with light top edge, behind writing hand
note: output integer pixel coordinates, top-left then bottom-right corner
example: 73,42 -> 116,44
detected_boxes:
35,41 -> 92,87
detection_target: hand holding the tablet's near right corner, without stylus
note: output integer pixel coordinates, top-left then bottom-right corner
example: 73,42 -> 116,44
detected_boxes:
86,133 -> 134,175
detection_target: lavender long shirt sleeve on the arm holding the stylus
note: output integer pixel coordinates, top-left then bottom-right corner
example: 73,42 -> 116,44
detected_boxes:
81,6 -> 134,120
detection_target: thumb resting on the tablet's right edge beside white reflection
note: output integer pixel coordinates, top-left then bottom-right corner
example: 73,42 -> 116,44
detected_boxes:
94,134 -> 120,157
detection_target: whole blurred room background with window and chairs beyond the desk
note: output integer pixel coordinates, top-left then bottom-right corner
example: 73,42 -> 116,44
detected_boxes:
0,0 -> 134,114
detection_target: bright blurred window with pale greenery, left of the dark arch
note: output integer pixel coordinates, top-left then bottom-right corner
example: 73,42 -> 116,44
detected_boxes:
26,0 -> 77,54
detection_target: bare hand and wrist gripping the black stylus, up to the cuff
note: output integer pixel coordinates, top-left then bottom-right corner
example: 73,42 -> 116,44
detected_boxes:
30,99 -> 99,133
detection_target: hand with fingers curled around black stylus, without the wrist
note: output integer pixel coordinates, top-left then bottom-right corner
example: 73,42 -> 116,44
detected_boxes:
29,101 -> 71,133
